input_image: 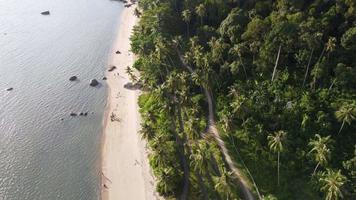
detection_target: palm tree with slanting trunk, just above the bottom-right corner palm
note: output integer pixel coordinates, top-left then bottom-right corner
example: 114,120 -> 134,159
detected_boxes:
308,134 -> 331,175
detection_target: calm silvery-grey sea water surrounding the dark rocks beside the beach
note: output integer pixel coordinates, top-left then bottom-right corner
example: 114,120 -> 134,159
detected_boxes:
0,0 -> 123,200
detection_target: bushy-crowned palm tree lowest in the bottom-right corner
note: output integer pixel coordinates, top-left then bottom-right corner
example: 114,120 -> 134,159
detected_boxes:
319,169 -> 347,200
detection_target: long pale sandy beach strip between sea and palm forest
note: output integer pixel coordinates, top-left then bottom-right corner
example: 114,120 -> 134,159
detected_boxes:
101,6 -> 157,200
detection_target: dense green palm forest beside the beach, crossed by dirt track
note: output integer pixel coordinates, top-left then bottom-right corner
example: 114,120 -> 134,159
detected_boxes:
131,0 -> 356,200
